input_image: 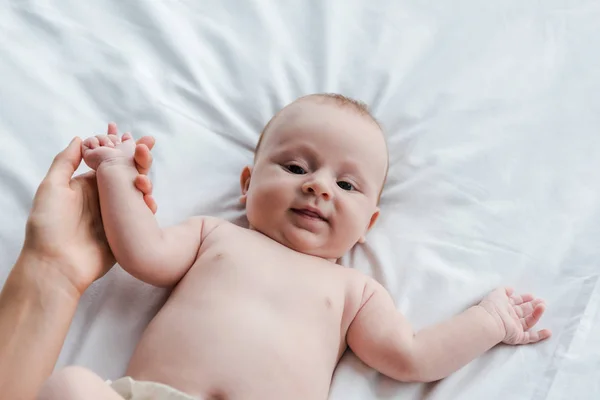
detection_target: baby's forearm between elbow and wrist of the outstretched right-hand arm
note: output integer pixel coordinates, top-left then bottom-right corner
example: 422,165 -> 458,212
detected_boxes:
410,306 -> 503,382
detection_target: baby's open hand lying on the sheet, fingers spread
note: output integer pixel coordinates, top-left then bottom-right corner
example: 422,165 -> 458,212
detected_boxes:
479,288 -> 551,345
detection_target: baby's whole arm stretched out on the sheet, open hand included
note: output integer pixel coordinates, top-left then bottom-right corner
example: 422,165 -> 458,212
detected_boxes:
347,281 -> 550,382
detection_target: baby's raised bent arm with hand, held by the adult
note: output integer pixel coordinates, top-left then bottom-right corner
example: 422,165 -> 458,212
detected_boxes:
83,134 -> 217,286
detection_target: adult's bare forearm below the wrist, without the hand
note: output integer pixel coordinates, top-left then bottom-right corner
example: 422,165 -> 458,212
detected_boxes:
0,253 -> 79,400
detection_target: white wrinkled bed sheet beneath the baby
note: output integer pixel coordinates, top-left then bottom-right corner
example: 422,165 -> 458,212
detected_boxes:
0,0 -> 600,400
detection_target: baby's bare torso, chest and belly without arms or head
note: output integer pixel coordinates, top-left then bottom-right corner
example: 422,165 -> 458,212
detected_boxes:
127,220 -> 367,399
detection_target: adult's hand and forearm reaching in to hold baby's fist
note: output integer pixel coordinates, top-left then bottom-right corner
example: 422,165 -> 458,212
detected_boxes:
0,124 -> 156,400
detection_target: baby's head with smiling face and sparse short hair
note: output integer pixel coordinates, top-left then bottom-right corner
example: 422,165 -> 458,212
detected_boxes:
241,98 -> 387,259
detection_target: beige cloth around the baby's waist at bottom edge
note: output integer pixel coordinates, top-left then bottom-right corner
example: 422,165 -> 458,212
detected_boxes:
107,376 -> 198,400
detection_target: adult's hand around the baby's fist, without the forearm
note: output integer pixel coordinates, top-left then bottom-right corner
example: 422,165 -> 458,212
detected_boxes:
22,124 -> 156,294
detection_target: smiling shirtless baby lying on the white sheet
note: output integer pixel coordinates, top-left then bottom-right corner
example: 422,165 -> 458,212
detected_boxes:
40,94 -> 550,400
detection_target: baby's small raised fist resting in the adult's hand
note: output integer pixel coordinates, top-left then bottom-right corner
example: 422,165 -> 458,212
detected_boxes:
81,133 -> 135,171
